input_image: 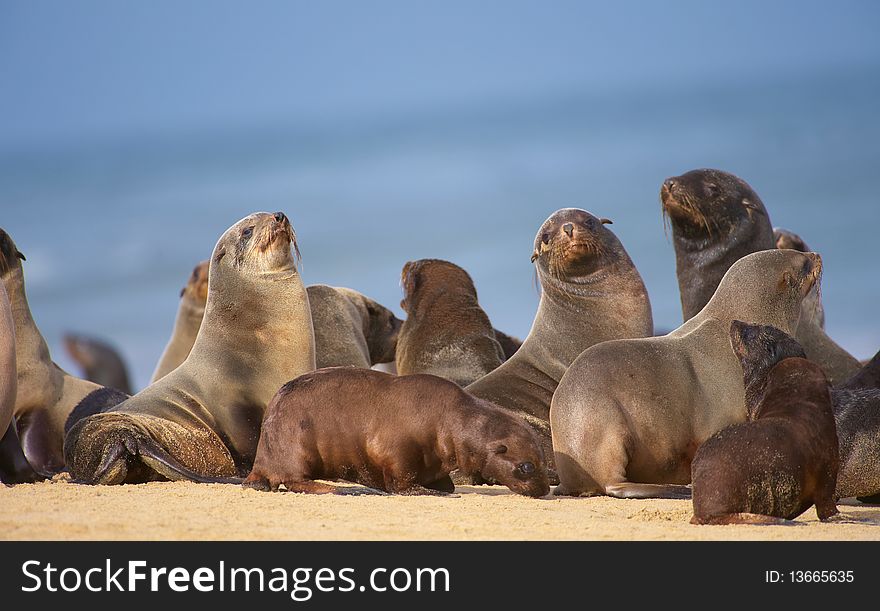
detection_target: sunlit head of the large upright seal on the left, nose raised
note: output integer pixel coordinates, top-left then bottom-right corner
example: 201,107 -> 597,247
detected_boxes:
211,212 -> 299,276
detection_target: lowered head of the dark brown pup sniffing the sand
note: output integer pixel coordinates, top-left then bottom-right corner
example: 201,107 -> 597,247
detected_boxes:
480,420 -> 550,498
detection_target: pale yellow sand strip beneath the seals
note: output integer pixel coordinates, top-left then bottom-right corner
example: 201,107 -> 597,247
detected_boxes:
0,481 -> 880,541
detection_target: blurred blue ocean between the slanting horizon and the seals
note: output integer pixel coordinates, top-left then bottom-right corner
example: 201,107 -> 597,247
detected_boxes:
0,66 -> 880,388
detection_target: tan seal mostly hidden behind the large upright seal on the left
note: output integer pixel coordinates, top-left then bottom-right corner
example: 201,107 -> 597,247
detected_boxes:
150,261 -> 210,384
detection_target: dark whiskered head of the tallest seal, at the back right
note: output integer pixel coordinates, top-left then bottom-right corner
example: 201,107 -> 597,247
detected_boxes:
660,169 -> 767,240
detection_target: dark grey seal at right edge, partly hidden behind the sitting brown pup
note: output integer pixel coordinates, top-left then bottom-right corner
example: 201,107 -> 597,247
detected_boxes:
734,324 -> 880,502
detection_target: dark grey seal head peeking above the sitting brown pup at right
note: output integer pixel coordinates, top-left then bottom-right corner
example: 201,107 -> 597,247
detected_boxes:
730,320 -> 807,419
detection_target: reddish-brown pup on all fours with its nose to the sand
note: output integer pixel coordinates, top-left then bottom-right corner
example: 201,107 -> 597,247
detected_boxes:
244,367 -> 550,497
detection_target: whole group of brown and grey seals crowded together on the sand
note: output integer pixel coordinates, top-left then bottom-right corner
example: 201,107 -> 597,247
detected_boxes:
0,165 -> 880,524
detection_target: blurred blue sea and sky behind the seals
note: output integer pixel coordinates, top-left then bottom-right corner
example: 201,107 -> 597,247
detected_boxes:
0,0 -> 880,388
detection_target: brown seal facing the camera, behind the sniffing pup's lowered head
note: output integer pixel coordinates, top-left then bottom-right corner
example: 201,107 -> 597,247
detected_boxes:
465,208 -> 654,479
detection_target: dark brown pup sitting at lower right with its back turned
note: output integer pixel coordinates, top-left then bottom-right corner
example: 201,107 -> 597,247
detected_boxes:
691,321 -> 838,524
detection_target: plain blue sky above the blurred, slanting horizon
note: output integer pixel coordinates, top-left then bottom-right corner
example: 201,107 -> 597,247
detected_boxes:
0,0 -> 880,151
